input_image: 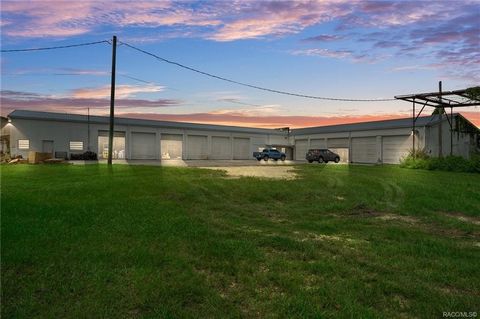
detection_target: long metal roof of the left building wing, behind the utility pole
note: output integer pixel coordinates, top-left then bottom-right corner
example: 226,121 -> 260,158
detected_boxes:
8,110 -> 286,135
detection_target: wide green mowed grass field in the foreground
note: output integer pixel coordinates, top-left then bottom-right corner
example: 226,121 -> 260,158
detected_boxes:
1,164 -> 480,318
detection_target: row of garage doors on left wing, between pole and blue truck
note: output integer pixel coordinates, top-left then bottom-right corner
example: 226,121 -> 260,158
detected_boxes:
131,132 -> 251,159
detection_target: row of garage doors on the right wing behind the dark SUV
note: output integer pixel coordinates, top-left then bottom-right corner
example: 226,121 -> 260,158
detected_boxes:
295,135 -> 412,164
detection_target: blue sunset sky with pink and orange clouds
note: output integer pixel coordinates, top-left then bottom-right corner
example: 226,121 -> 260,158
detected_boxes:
0,0 -> 480,128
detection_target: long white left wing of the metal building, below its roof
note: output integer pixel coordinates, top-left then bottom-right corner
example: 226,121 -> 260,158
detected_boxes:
2,110 -> 288,160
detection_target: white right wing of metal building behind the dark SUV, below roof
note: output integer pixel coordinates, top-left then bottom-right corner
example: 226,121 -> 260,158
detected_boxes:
293,114 -> 480,164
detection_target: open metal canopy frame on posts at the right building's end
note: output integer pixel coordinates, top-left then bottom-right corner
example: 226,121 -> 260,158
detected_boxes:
395,81 -> 480,157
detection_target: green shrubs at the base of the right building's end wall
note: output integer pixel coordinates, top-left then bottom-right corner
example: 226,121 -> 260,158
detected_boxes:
400,150 -> 480,173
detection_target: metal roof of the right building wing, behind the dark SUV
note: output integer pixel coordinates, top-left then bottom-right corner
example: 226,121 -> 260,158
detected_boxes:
292,113 -> 458,135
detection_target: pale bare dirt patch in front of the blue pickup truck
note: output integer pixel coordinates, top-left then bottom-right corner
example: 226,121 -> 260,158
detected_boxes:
204,166 -> 297,180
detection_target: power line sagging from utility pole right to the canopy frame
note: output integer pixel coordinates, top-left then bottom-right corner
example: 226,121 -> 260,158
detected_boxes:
119,41 -> 396,102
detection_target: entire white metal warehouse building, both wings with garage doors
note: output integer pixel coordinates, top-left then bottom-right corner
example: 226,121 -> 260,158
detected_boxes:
2,110 -> 480,164
